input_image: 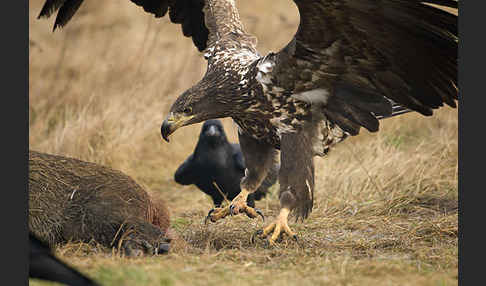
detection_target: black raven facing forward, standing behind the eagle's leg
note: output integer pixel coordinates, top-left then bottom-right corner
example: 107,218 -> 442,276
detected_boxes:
174,119 -> 278,207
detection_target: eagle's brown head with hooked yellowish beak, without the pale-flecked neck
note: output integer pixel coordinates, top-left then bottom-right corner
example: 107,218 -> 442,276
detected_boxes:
160,77 -> 232,142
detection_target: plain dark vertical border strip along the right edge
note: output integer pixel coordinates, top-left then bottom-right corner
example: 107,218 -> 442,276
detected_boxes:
458,0 -> 480,285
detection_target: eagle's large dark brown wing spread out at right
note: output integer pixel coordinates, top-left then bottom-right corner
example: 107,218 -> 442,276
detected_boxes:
266,0 -> 458,135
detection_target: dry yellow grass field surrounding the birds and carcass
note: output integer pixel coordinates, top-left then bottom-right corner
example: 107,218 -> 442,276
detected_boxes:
29,0 -> 458,286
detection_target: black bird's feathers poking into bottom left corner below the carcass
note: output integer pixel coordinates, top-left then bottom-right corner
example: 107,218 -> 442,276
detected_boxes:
29,233 -> 98,286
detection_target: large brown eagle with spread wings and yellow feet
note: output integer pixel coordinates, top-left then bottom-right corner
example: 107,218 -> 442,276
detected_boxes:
39,0 -> 459,244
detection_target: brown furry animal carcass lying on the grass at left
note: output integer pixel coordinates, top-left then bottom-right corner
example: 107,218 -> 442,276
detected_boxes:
29,151 -> 171,255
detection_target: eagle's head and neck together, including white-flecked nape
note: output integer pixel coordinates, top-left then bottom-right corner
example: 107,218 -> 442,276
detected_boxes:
160,45 -> 259,142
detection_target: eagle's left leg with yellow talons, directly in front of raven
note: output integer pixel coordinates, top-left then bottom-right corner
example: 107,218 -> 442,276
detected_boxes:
206,132 -> 278,222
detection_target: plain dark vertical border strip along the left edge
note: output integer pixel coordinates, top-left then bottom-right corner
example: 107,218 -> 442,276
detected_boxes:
4,1 -> 29,285
